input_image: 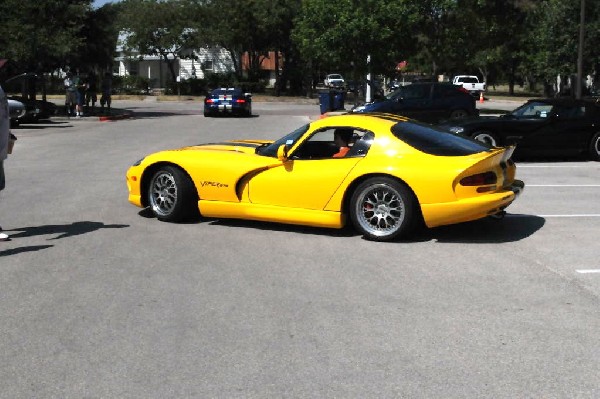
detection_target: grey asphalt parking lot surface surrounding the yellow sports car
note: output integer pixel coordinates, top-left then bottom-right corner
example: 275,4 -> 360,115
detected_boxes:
0,101 -> 600,398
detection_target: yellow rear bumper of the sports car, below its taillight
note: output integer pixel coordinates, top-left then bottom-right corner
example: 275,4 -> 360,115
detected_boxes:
421,180 -> 525,227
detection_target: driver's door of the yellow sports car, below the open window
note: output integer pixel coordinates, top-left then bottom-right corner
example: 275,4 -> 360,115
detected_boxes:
249,128 -> 366,210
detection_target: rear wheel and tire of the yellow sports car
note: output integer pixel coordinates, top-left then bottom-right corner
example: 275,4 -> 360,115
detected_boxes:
349,177 -> 418,241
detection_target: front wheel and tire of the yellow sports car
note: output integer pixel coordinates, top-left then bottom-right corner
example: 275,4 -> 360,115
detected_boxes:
146,166 -> 199,223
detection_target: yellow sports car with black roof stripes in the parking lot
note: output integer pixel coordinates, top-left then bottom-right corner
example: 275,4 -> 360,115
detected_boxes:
127,114 -> 524,241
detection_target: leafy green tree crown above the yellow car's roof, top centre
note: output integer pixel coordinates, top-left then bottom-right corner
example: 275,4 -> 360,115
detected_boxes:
292,0 -> 418,93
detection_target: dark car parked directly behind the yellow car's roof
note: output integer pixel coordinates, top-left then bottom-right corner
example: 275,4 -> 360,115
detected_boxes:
352,82 -> 479,123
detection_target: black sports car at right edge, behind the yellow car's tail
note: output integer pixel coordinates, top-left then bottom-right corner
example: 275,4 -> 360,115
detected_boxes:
440,98 -> 600,161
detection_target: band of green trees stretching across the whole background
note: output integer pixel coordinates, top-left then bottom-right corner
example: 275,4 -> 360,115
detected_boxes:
0,0 -> 600,93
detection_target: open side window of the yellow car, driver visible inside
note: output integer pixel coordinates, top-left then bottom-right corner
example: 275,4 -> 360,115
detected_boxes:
290,127 -> 374,159
